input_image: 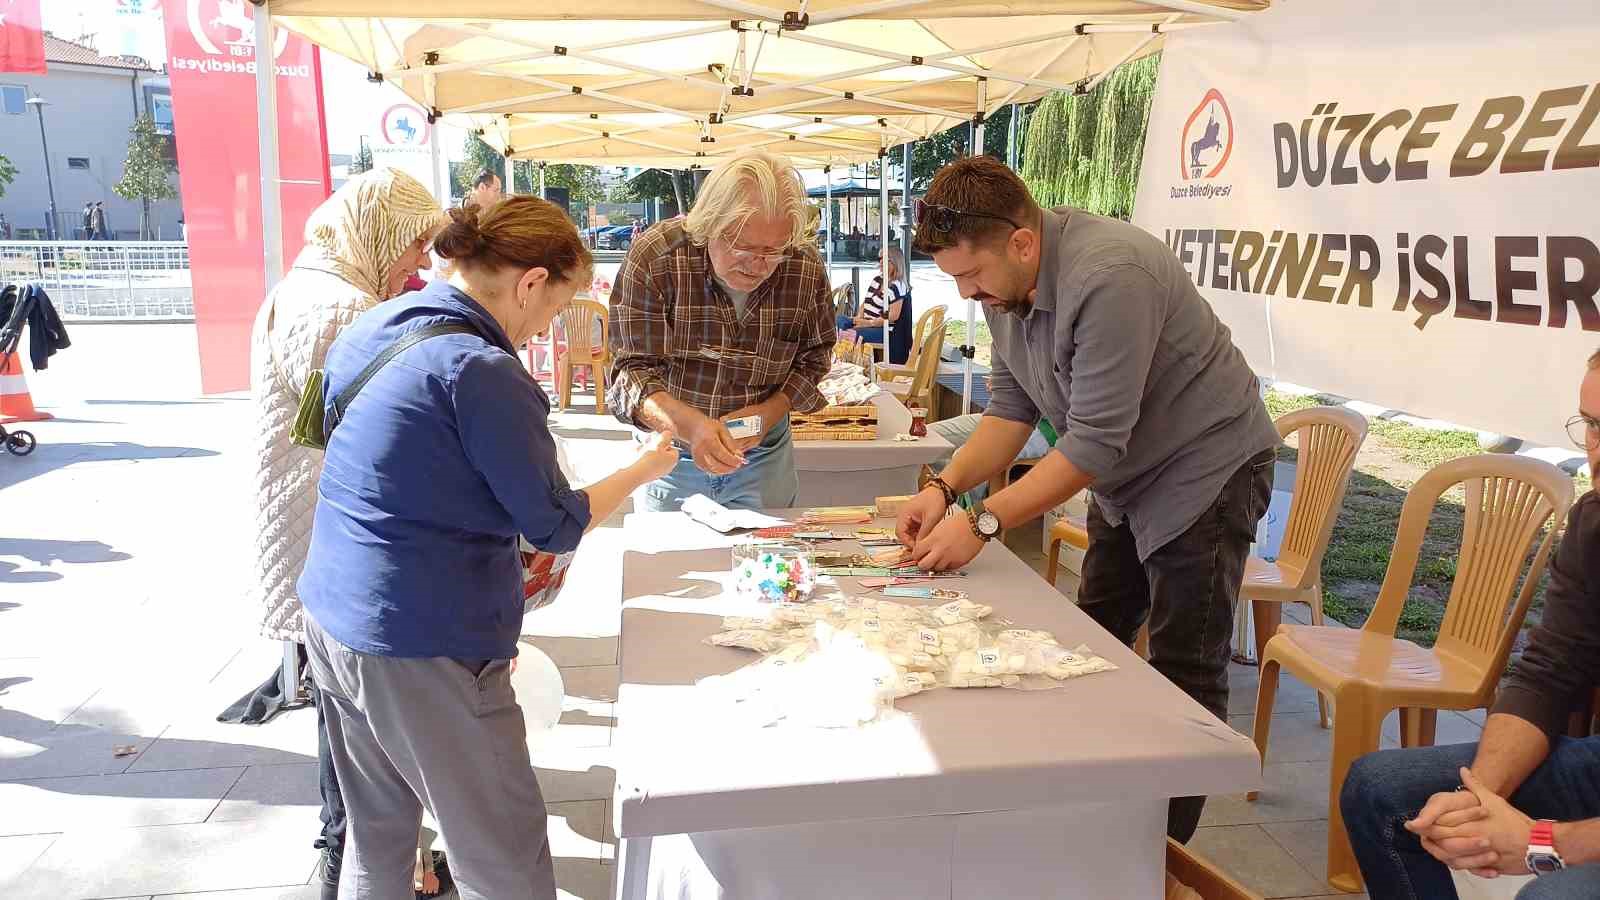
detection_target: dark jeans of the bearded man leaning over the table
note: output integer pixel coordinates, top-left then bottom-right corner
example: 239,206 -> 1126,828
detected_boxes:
1078,450 -> 1275,842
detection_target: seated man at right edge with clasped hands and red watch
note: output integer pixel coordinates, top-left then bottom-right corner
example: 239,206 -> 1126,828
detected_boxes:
1339,352 -> 1600,900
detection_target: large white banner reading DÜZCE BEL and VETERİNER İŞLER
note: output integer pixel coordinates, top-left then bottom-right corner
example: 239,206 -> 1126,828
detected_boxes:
1134,0 -> 1600,445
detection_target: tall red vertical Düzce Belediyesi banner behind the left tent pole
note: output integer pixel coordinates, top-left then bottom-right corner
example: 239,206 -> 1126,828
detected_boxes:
164,0 -> 331,394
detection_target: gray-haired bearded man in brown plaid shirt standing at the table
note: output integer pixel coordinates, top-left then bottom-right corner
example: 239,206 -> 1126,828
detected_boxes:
606,152 -> 835,511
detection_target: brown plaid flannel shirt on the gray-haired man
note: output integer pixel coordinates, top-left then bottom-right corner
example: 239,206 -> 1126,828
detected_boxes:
606,221 -> 835,424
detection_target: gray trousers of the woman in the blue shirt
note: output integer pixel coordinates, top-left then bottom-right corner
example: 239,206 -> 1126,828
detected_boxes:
306,615 -> 555,900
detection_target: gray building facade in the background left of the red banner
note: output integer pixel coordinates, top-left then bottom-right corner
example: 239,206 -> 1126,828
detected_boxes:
0,34 -> 182,240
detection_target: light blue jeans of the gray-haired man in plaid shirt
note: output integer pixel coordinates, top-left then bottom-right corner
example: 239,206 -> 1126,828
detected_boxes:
640,416 -> 800,512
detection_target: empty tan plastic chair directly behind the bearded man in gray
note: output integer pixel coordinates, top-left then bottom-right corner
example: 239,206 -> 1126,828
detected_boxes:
1238,407 -> 1366,729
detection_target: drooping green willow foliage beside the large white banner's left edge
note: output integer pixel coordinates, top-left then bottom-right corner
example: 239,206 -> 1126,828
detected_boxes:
1021,54 -> 1160,219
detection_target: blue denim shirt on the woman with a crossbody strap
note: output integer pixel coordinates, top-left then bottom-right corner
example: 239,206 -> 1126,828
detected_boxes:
299,282 -> 589,660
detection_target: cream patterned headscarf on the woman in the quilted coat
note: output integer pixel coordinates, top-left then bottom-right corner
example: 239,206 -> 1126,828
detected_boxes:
294,168 -> 446,299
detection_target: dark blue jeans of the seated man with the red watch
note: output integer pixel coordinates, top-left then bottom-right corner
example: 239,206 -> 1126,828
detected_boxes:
1339,737 -> 1600,900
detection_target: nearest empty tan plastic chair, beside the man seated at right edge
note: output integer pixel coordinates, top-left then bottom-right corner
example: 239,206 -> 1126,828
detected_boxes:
1248,453 -> 1573,892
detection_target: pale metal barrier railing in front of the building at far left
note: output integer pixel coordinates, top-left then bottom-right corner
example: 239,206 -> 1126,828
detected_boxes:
0,240 -> 195,319
